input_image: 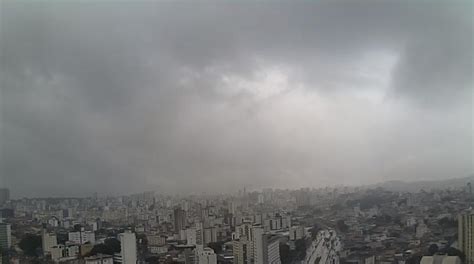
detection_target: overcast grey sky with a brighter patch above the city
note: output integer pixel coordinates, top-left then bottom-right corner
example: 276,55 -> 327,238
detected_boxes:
0,0 -> 474,197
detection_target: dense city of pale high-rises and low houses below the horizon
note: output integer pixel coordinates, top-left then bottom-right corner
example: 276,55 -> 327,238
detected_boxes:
0,184 -> 474,264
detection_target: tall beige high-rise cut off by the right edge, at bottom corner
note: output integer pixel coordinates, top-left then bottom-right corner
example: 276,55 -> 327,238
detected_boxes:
458,212 -> 474,264
